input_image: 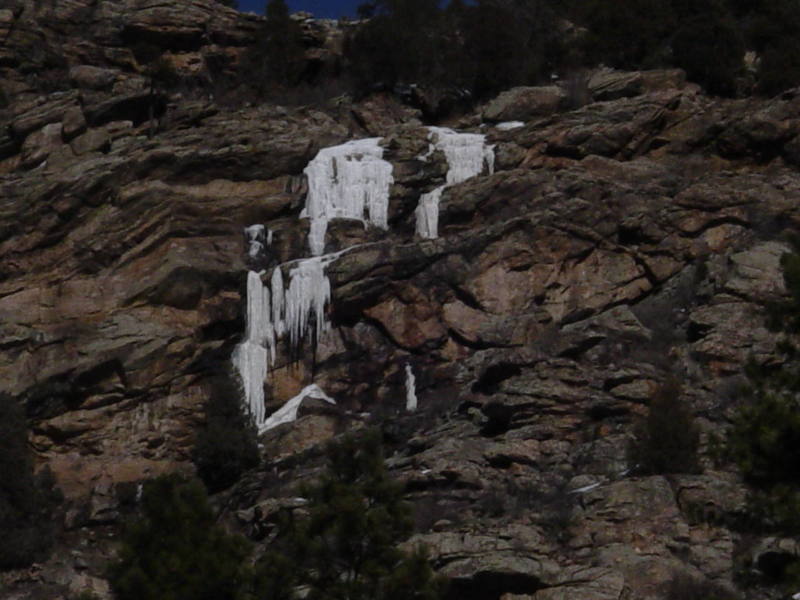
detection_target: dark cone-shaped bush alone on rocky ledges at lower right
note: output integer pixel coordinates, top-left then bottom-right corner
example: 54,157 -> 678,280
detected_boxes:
629,379 -> 700,475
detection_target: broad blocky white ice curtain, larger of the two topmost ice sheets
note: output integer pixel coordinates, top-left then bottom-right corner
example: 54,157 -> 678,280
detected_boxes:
300,138 -> 394,256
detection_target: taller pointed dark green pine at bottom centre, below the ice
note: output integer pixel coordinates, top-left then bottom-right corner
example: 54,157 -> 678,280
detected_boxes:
255,431 -> 443,600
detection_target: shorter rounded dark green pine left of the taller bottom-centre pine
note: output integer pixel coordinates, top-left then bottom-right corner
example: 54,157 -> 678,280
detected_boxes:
109,475 -> 250,600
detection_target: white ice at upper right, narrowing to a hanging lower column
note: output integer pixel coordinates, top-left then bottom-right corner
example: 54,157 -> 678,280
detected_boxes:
415,127 -> 494,239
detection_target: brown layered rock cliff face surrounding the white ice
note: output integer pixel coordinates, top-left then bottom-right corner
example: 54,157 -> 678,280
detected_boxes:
0,0 -> 800,600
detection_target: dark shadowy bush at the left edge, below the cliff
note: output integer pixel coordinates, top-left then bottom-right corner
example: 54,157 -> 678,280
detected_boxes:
0,394 -> 61,569
